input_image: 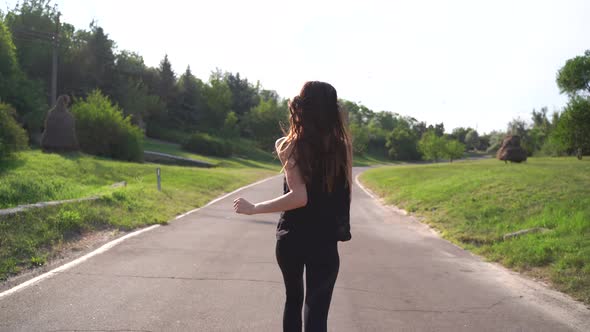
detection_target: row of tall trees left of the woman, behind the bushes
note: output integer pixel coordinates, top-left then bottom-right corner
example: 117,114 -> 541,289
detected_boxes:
0,0 -> 288,150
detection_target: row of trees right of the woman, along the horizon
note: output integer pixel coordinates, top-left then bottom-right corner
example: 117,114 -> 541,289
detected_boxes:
344,46 -> 590,160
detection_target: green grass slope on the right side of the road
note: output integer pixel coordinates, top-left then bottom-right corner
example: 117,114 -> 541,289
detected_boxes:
361,158 -> 590,303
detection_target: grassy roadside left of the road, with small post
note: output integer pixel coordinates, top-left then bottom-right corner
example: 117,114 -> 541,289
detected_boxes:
0,151 -> 280,280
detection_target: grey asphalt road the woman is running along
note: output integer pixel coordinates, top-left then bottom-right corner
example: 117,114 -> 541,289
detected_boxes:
0,169 -> 590,332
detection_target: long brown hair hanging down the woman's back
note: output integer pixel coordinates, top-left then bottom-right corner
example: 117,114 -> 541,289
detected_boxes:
279,81 -> 352,192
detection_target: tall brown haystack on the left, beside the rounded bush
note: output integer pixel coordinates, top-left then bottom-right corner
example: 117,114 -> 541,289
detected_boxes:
41,95 -> 80,152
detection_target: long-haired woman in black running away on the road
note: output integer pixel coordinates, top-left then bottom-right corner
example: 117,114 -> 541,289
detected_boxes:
234,81 -> 352,332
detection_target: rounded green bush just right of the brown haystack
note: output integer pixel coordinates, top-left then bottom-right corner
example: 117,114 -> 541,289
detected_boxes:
72,90 -> 143,161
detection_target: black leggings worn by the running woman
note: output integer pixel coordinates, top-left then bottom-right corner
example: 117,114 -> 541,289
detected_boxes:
276,236 -> 340,332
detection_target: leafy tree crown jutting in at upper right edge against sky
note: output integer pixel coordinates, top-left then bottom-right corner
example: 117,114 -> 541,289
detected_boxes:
557,50 -> 590,96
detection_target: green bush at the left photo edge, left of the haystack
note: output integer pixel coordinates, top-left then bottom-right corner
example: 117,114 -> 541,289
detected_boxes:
0,103 -> 27,160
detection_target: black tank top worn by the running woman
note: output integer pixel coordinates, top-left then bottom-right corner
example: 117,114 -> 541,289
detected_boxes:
276,165 -> 350,242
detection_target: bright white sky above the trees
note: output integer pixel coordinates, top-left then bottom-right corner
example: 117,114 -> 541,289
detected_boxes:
0,0 -> 590,133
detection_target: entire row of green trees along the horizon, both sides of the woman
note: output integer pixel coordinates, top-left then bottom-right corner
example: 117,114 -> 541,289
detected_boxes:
0,0 -> 590,160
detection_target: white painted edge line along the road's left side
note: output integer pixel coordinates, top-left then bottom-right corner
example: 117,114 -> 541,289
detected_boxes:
0,174 -> 280,299
